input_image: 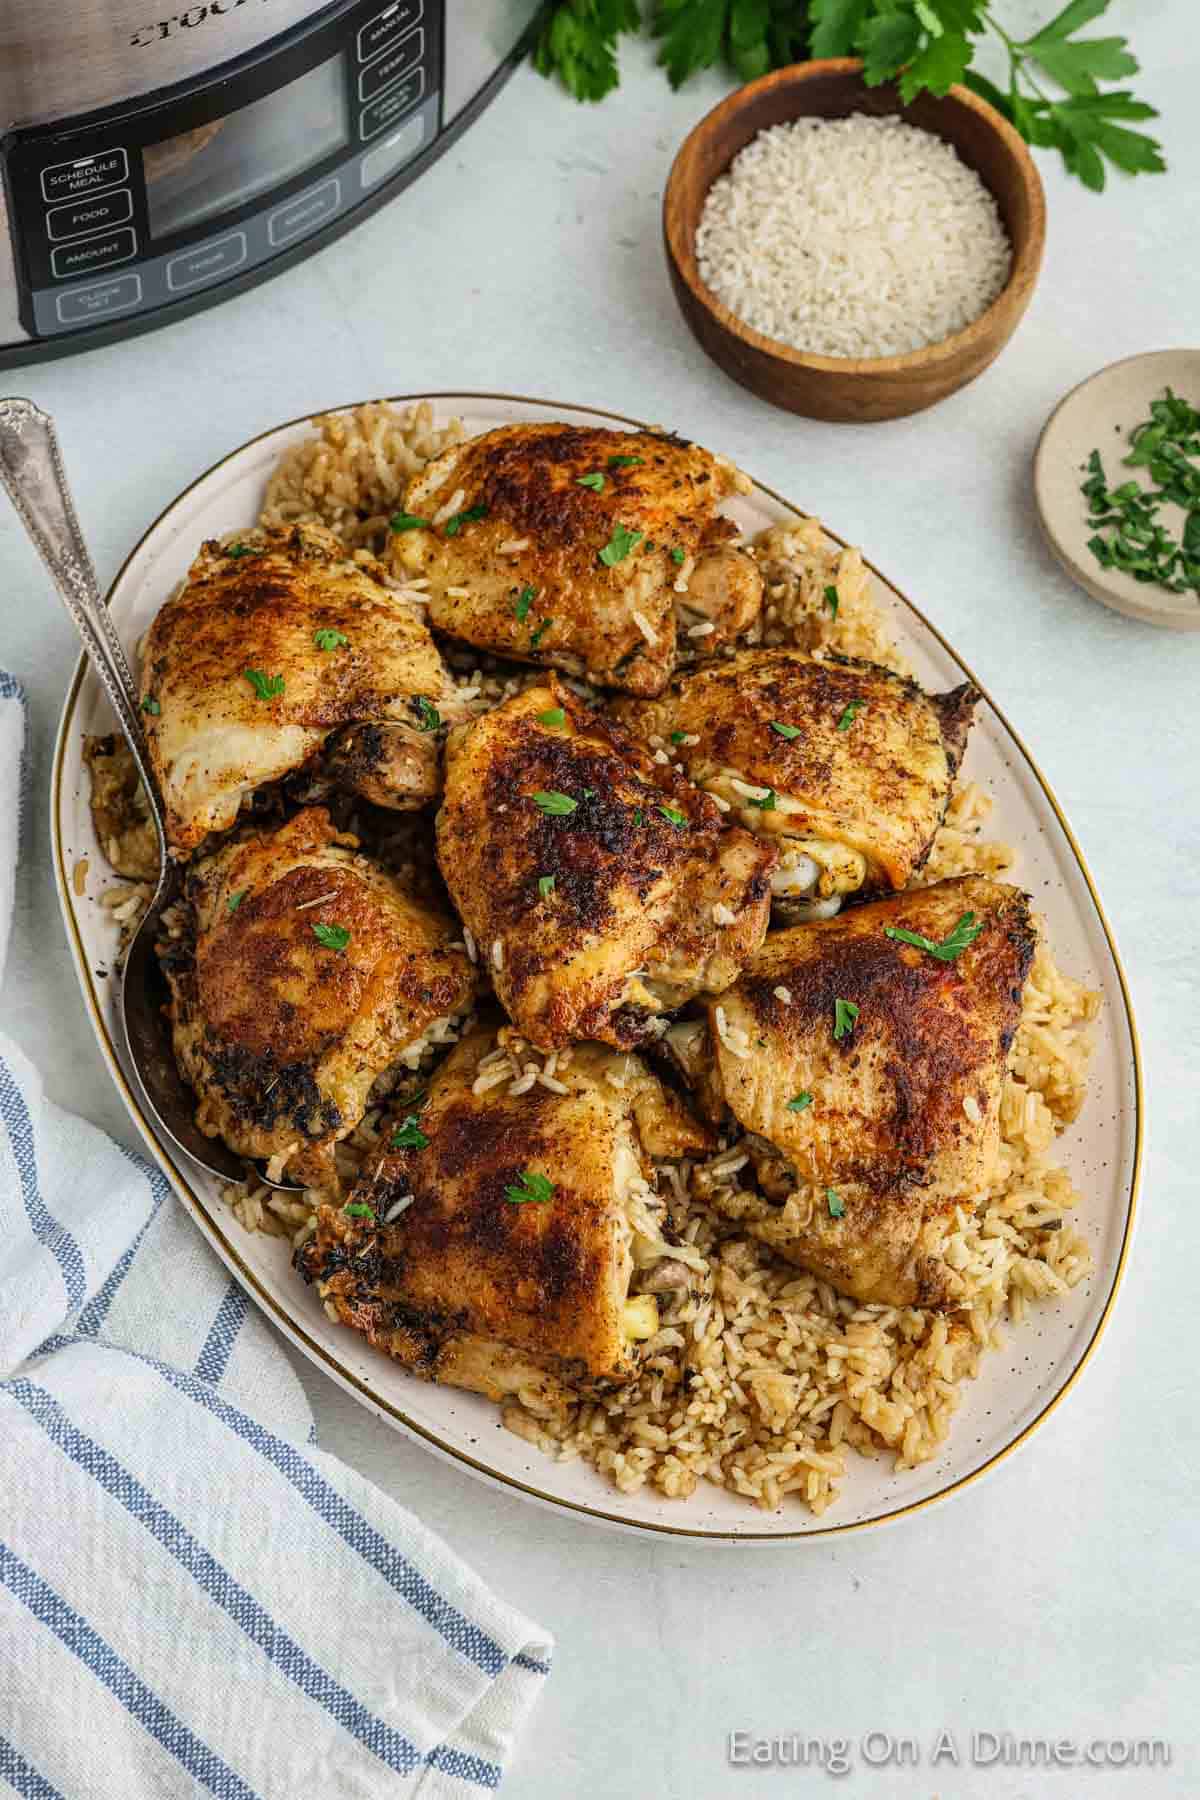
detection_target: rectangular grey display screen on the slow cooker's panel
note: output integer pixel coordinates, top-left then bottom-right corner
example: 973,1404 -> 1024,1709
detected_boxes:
142,56 -> 351,238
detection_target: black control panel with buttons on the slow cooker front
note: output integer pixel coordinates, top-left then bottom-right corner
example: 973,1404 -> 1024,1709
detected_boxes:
4,0 -> 443,338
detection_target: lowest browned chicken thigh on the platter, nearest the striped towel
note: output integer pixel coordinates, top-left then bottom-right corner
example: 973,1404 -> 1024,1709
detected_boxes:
295,1028 -> 711,1399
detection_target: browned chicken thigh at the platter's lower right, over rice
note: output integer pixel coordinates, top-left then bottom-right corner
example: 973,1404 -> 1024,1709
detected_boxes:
691,877 -> 1036,1307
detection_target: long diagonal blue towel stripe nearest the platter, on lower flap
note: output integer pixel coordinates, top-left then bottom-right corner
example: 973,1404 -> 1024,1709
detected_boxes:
41,1332 -> 509,1676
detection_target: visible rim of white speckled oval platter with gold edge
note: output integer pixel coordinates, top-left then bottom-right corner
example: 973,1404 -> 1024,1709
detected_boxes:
50,394 -> 1142,1543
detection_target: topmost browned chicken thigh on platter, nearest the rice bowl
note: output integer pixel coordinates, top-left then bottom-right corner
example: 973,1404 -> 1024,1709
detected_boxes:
390,425 -> 757,693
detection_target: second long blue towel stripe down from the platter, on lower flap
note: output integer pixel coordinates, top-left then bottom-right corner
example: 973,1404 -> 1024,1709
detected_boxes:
0,1379 -> 429,1786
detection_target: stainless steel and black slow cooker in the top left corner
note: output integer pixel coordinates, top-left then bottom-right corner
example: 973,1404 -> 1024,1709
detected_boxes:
0,0 -> 536,367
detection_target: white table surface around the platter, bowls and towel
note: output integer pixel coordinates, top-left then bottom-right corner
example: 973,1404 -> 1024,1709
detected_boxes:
0,0 -> 1200,1800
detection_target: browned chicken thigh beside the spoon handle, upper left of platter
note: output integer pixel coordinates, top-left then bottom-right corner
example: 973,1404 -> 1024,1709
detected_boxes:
142,526 -> 457,857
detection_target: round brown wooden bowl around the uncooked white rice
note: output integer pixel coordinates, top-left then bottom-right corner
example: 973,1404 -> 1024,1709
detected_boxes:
662,58 -> 1045,423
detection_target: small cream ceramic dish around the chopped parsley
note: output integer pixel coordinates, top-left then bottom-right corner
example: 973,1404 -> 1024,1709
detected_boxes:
1033,349 -> 1200,632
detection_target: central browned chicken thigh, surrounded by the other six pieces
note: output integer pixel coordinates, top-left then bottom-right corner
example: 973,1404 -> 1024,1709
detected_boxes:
437,677 -> 775,1049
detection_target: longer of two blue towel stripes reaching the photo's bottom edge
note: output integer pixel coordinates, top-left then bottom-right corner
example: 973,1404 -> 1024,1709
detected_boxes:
0,1543 -> 259,1800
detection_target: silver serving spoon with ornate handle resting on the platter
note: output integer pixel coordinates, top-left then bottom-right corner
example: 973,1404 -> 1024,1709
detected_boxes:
0,400 -> 300,1188
